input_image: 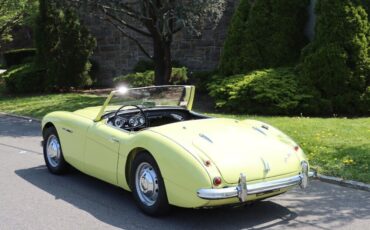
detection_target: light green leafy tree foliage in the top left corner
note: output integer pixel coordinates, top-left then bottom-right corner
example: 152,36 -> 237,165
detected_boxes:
0,0 -> 36,47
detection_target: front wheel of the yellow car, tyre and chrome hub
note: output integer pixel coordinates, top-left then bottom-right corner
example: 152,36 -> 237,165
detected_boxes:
43,127 -> 68,174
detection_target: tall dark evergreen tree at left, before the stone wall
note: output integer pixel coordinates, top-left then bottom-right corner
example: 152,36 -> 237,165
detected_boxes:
36,0 -> 96,90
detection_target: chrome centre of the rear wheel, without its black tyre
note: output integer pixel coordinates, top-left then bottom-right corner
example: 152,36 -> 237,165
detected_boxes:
135,162 -> 159,206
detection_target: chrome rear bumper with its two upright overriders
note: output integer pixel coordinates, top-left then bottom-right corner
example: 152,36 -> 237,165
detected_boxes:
197,163 -> 313,202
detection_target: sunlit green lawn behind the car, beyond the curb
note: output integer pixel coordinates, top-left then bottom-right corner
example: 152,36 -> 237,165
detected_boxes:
0,94 -> 370,183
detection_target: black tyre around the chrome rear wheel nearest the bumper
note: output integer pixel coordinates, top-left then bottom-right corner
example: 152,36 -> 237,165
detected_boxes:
130,152 -> 170,216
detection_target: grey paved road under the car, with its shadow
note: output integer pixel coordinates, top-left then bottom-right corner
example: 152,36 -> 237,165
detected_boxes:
0,115 -> 370,229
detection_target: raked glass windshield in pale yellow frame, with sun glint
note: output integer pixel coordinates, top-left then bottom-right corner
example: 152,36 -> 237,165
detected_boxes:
96,86 -> 195,120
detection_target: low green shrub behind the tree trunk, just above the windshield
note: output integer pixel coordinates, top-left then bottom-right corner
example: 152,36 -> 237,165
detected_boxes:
113,67 -> 188,87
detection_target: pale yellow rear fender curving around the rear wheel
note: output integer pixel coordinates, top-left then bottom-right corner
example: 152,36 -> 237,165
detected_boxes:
117,132 -> 212,208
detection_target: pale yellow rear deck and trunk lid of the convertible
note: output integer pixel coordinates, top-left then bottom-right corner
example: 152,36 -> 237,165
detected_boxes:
151,118 -> 300,183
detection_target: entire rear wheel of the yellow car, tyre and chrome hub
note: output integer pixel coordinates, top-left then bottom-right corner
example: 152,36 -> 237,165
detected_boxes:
130,153 -> 170,216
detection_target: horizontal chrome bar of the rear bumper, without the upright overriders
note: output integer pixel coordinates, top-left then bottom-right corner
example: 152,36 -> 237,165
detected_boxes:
197,175 -> 302,201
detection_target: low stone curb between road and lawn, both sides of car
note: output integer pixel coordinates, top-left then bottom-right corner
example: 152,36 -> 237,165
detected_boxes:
0,112 -> 370,192
